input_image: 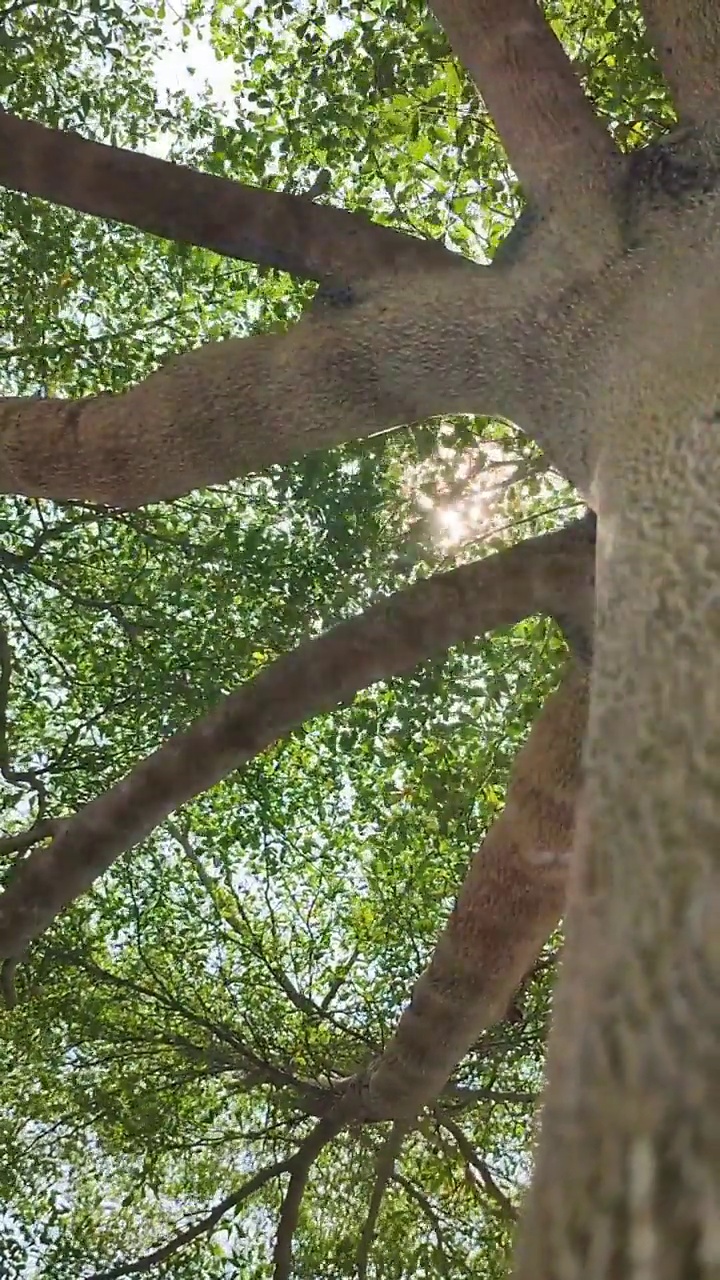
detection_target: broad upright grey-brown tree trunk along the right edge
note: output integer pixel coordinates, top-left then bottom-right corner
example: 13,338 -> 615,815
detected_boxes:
516,230 -> 720,1280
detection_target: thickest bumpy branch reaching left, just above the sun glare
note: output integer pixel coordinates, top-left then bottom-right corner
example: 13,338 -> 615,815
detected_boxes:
0,252 -> 538,507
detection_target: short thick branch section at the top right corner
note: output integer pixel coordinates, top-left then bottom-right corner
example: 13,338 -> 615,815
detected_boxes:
641,0 -> 720,124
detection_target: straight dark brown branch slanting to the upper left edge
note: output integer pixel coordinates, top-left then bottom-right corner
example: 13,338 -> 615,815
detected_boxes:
0,111 -> 456,282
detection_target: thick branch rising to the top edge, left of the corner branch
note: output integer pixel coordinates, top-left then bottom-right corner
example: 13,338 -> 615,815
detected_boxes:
430,0 -> 620,220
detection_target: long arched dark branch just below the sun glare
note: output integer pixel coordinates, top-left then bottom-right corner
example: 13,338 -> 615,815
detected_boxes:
0,521 -> 594,959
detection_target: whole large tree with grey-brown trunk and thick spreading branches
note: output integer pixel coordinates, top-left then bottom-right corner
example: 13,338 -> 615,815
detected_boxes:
0,0 -> 720,1280
